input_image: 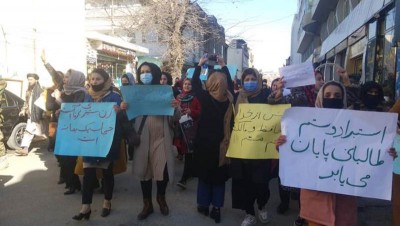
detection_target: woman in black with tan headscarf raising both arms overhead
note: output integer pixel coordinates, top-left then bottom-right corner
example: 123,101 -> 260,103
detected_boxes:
192,57 -> 233,223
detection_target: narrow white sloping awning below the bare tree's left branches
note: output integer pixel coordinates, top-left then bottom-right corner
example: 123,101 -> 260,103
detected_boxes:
86,31 -> 149,54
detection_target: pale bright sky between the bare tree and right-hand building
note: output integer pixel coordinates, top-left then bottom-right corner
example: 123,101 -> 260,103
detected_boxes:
203,0 -> 297,72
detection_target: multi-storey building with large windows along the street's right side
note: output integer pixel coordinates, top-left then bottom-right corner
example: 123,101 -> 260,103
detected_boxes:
288,0 -> 400,101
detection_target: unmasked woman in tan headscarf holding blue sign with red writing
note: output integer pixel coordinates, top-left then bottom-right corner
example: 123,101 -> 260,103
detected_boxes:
72,69 -> 123,220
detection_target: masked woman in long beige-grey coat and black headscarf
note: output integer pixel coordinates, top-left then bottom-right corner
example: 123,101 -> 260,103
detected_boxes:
122,62 -> 179,220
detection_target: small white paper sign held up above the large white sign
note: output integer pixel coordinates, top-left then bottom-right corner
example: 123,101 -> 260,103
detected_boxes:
279,62 -> 315,88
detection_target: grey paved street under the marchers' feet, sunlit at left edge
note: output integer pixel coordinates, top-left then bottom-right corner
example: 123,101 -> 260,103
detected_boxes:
0,142 -> 391,226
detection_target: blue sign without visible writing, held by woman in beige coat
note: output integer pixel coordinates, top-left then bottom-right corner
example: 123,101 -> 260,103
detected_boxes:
121,85 -> 174,120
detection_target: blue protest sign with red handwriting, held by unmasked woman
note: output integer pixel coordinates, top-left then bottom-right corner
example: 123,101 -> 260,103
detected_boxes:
54,102 -> 116,157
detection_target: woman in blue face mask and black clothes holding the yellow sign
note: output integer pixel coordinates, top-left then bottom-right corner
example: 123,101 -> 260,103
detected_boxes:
230,68 -> 271,226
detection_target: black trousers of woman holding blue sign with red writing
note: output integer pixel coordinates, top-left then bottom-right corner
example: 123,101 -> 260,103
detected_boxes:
82,162 -> 114,204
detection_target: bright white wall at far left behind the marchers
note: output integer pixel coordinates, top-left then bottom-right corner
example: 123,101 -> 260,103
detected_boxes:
0,0 -> 86,95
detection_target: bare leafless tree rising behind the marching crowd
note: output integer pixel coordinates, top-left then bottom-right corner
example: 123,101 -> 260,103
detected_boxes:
86,0 -> 225,75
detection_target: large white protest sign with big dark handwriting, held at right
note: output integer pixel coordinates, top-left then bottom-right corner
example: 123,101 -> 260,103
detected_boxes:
279,107 -> 397,200
